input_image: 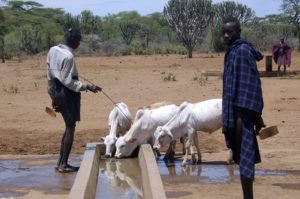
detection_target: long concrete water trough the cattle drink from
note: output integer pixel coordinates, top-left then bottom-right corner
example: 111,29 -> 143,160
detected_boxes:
69,143 -> 166,199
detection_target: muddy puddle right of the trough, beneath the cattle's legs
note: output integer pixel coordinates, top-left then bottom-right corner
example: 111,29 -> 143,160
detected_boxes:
157,156 -> 297,184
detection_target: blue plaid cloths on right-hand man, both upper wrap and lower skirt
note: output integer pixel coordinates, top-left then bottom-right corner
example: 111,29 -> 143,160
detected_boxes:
222,39 -> 263,179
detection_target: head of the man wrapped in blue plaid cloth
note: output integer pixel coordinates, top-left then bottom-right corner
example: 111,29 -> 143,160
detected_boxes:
222,17 -> 241,46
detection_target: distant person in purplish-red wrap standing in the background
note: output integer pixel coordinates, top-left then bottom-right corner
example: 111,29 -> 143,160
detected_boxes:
272,37 -> 292,76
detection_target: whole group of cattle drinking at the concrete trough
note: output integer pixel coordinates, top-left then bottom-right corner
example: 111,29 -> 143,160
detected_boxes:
102,99 -> 232,166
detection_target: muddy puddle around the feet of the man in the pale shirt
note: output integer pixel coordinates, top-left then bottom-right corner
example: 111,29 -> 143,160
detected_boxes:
0,155 -> 82,198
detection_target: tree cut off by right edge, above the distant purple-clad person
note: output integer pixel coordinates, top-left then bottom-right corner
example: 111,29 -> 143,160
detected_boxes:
281,0 -> 300,50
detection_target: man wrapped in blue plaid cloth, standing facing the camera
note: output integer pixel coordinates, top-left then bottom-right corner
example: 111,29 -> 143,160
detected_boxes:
222,17 -> 265,199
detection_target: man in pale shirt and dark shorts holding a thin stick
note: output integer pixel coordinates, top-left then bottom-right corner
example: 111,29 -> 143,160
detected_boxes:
47,28 -> 101,173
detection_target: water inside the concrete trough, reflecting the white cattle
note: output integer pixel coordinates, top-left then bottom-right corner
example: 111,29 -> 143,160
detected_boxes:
95,158 -> 143,199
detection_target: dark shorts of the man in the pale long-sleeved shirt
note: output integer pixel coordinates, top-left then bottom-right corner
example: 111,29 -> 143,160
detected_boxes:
54,80 -> 81,126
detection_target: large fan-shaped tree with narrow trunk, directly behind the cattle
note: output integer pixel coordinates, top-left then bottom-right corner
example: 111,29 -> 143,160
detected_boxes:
163,0 -> 214,58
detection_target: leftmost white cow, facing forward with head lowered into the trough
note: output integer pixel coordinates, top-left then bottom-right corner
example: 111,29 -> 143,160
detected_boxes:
102,102 -> 132,157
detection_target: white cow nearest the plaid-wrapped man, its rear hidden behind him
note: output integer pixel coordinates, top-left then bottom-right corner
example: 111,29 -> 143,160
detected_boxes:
153,99 -> 231,166
